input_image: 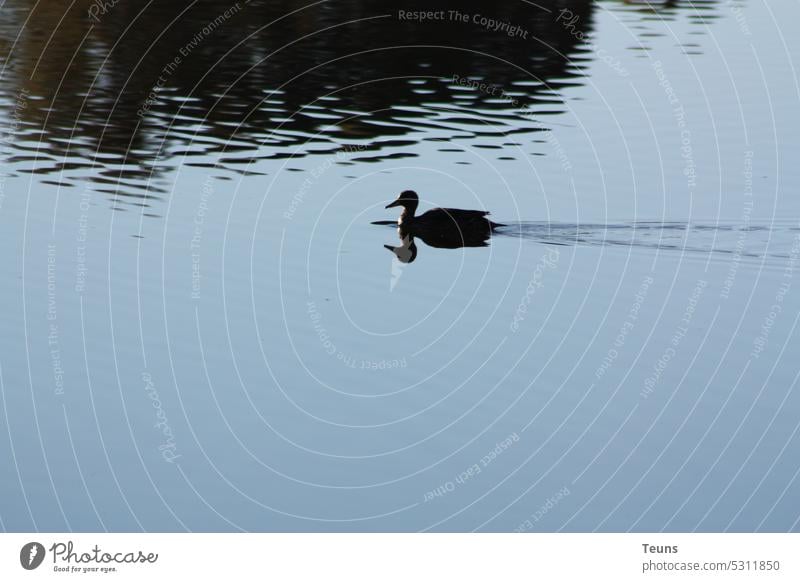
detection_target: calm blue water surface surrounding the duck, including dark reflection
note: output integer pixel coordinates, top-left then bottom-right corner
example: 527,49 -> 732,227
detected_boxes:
0,0 -> 800,531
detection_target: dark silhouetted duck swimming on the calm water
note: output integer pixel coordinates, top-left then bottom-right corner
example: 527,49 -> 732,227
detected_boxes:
386,190 -> 505,249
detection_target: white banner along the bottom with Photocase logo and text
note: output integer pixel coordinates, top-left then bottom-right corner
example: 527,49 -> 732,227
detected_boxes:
0,533 -> 800,582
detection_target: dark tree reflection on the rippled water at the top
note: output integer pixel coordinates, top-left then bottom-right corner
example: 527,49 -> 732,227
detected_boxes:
0,0 -> 720,198
